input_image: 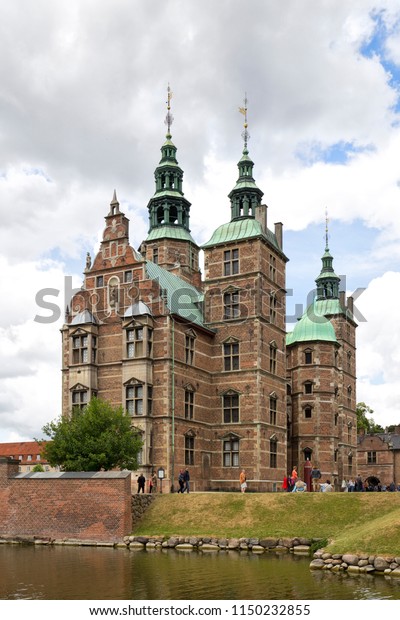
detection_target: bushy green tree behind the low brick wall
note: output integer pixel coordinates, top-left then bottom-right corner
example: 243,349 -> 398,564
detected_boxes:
42,398 -> 143,471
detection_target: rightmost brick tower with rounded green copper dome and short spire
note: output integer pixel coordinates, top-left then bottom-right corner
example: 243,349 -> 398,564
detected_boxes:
286,227 -> 357,489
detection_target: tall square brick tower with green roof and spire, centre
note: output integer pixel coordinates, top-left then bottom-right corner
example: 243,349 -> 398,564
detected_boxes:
202,99 -> 287,491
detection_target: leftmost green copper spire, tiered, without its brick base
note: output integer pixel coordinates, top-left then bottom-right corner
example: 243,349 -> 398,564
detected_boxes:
147,85 -> 190,233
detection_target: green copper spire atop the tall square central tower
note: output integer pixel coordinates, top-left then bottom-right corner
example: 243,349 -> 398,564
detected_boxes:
229,96 -> 263,221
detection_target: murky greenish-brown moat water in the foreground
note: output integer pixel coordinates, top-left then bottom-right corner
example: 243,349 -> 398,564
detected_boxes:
0,544 -> 400,600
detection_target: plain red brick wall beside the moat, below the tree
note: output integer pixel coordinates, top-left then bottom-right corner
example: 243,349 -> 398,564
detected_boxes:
0,457 -> 132,542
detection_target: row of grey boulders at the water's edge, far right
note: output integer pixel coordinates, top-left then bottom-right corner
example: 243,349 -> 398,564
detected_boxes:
310,549 -> 400,578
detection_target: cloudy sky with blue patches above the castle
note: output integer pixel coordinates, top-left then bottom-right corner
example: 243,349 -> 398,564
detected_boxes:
0,0 -> 400,441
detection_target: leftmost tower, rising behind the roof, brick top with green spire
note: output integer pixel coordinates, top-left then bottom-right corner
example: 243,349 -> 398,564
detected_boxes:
140,86 -> 200,286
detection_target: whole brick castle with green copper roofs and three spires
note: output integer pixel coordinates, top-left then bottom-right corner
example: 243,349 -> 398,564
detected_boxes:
61,96 -> 357,491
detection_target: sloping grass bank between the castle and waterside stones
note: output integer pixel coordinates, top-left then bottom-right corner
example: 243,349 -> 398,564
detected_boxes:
133,492 -> 400,556
